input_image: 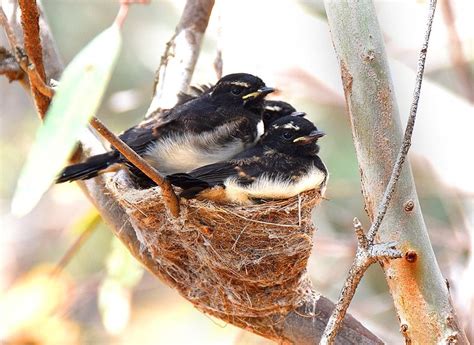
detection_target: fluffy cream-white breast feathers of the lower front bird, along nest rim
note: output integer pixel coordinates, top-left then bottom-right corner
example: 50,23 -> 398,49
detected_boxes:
224,167 -> 327,204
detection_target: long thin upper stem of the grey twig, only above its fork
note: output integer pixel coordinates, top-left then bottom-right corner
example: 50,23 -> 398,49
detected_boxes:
367,0 -> 437,244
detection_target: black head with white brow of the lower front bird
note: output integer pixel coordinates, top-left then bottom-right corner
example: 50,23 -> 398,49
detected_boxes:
261,115 -> 325,156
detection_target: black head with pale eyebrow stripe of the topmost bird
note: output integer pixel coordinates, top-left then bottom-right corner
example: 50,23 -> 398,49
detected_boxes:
210,73 -> 274,112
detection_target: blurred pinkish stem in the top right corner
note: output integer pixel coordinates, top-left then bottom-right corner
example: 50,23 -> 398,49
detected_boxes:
441,0 -> 474,103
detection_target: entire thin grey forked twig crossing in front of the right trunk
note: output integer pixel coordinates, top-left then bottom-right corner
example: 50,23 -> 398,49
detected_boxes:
320,0 -> 436,344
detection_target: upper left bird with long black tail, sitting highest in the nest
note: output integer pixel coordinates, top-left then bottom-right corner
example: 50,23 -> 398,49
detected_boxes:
56,73 -> 274,187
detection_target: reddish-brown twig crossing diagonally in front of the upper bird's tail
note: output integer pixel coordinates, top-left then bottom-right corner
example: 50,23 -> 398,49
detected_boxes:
91,117 -> 179,217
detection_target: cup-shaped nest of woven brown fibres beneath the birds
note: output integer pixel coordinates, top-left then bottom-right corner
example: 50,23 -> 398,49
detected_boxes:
107,173 -> 322,319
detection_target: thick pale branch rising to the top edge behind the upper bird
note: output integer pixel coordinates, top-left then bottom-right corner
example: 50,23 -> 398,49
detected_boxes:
146,0 -> 214,117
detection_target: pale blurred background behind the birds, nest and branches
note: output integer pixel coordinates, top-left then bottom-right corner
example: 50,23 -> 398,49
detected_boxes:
0,0 -> 474,345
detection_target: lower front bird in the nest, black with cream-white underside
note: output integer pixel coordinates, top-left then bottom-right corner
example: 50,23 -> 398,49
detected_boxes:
166,116 -> 328,205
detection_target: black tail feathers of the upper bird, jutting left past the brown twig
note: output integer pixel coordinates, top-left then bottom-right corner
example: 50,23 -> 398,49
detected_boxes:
56,152 -> 120,183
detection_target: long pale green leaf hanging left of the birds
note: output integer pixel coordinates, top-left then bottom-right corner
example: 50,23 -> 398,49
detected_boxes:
12,25 -> 122,216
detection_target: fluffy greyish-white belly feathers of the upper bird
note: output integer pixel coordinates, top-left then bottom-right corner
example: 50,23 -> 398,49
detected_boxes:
144,121 -> 263,175
